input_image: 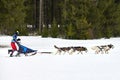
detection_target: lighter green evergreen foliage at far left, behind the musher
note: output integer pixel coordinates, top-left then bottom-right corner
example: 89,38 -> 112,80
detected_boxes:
0,0 -> 26,33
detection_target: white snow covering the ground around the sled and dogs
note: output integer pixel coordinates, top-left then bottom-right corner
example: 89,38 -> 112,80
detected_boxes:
0,36 -> 120,80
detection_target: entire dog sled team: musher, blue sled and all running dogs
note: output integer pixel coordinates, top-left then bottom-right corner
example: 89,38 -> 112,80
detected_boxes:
8,31 -> 114,57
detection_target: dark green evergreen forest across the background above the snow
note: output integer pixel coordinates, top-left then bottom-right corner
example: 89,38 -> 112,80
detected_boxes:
0,0 -> 120,39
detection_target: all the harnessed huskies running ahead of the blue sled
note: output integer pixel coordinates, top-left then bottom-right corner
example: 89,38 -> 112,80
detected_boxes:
54,44 -> 114,55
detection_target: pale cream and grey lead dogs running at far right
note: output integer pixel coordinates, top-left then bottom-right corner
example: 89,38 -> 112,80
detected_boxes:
91,44 -> 114,54
